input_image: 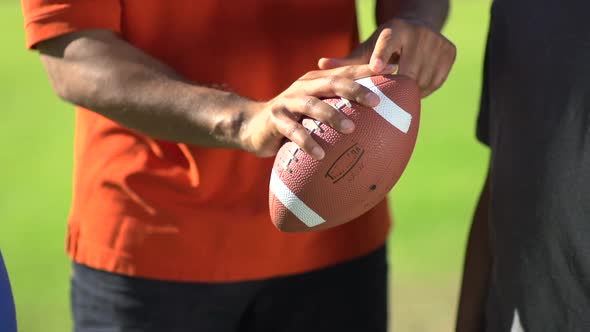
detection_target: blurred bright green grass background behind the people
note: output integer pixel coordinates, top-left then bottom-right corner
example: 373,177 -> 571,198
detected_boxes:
0,0 -> 490,332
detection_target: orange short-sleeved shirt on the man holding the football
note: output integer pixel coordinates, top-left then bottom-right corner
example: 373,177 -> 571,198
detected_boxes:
22,0 -> 389,282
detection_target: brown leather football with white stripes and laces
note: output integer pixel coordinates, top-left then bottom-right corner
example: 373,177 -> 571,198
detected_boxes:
269,75 -> 420,232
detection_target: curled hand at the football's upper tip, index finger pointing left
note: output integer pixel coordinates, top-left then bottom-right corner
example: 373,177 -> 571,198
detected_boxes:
318,18 -> 456,97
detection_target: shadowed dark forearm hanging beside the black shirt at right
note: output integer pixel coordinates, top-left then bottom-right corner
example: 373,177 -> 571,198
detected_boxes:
456,174 -> 492,332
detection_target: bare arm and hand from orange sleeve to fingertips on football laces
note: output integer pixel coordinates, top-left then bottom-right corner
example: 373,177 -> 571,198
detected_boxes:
37,30 -> 394,159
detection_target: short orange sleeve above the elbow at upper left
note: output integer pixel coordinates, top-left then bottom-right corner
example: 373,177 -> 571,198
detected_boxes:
21,0 -> 121,48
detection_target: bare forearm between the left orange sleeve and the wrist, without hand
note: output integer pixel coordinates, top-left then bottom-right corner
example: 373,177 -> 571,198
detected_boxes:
40,32 -> 255,148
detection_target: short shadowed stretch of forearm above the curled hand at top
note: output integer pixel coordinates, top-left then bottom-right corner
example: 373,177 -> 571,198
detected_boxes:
376,0 -> 449,31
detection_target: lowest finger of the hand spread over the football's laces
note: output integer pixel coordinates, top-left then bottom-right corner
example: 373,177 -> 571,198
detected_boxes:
272,106 -> 325,160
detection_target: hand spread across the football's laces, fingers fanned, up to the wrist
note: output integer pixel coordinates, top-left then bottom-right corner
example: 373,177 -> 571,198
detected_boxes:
240,65 -> 394,159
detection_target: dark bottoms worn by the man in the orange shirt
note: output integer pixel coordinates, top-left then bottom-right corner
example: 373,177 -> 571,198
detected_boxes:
71,247 -> 388,332
